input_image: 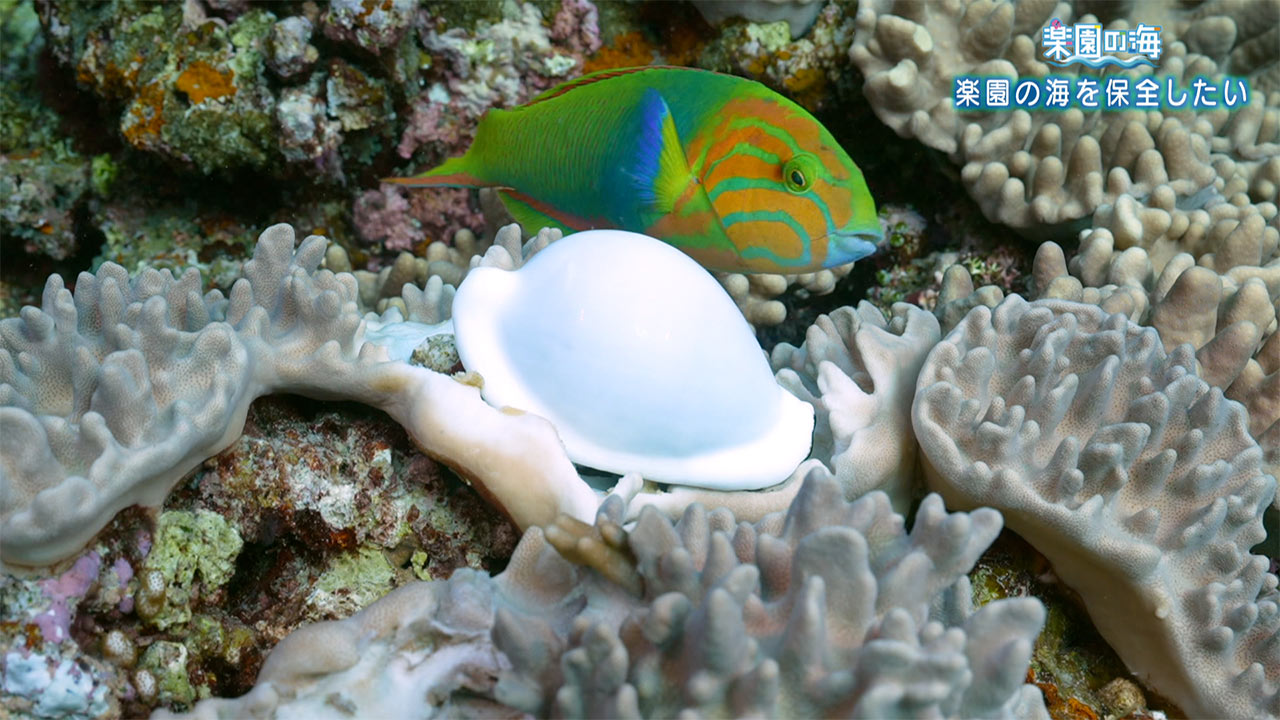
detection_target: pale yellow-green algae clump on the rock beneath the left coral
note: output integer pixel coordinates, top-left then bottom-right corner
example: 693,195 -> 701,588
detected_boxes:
138,510 -> 243,630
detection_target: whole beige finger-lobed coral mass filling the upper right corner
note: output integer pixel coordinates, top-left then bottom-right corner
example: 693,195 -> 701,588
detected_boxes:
850,0 -> 1280,476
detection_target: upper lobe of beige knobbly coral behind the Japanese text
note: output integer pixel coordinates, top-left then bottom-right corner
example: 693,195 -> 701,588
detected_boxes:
850,0 -> 1280,246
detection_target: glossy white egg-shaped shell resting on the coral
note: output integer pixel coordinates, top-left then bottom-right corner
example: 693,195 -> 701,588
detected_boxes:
453,231 -> 813,489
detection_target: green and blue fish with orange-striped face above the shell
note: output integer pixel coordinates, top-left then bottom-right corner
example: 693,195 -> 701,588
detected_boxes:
388,67 -> 882,273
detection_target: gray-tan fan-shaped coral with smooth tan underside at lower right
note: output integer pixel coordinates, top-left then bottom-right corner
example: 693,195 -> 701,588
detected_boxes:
913,296 -> 1280,716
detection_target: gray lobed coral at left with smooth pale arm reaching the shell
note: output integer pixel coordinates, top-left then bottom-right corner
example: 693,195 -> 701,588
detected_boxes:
0,225 -> 596,565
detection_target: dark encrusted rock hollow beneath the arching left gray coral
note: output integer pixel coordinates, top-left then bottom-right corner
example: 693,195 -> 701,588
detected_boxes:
0,389 -> 518,716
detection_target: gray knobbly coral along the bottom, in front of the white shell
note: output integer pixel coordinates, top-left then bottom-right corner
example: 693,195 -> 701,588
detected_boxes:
157,477 -> 1047,717
